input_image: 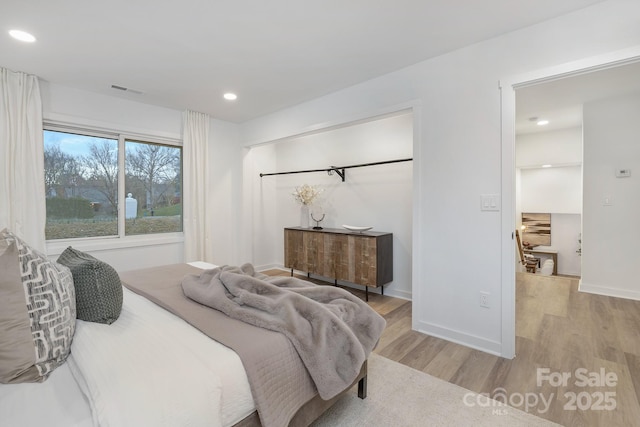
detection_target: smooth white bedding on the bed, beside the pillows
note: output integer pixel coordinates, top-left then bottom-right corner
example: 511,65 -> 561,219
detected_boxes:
0,260 -> 255,427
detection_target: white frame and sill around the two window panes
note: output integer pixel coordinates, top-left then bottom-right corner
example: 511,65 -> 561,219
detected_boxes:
43,121 -> 184,255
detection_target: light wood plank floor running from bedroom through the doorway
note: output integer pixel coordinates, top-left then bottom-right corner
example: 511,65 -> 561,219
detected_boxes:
266,270 -> 640,427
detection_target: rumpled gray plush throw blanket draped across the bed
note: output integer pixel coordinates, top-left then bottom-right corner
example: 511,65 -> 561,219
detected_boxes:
182,264 -> 386,400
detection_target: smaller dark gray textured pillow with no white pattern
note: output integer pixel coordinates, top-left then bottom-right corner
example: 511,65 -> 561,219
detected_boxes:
58,246 -> 122,325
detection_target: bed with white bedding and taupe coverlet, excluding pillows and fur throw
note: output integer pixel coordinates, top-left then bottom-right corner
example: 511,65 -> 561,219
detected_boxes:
0,229 -> 384,427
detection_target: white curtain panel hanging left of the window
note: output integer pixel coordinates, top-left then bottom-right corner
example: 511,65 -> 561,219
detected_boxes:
0,68 -> 46,252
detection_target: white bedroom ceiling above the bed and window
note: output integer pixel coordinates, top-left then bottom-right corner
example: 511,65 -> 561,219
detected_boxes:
0,0 -> 601,122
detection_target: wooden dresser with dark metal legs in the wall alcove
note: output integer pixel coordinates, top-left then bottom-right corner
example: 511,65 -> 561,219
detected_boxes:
284,227 -> 393,300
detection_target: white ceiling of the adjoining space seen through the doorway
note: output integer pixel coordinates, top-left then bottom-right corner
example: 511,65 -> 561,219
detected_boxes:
516,62 -> 640,134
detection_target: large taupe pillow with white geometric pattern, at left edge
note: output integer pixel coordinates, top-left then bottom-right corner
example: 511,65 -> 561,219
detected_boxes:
0,229 -> 76,384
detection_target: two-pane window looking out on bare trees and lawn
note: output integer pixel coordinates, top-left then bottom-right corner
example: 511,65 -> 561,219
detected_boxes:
44,126 -> 182,240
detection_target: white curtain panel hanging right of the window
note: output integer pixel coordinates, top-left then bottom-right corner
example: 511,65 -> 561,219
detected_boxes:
182,111 -> 214,262
